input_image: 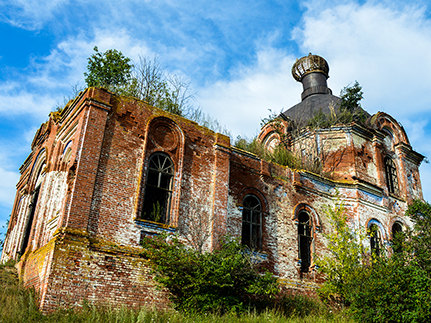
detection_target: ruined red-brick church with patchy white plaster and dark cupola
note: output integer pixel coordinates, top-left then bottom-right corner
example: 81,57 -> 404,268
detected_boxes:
1,54 -> 424,311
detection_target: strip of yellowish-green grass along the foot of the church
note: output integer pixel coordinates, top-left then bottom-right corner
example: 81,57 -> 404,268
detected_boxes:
0,264 -> 353,323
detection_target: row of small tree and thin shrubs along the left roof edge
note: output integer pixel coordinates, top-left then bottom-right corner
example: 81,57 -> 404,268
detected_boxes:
80,46 -> 230,135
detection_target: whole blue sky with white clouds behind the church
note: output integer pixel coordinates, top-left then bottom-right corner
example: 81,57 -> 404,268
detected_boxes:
0,0 -> 431,231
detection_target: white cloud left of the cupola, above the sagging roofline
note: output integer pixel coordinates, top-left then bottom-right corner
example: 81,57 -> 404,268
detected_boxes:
197,48 -> 302,137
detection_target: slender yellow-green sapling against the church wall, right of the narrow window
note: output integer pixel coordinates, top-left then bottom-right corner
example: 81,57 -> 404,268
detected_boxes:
316,193 -> 365,304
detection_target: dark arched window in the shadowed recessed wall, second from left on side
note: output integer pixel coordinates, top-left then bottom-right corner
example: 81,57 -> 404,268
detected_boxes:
241,195 -> 262,250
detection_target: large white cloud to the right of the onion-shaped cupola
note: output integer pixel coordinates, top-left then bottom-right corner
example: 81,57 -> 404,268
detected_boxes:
294,3 -> 431,117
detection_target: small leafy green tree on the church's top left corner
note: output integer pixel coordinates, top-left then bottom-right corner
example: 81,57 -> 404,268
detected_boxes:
84,46 -> 133,90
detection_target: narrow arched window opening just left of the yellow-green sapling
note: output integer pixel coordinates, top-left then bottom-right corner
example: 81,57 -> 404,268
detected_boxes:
298,211 -> 313,273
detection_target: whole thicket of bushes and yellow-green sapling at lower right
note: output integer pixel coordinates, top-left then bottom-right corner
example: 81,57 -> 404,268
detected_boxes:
317,200 -> 431,322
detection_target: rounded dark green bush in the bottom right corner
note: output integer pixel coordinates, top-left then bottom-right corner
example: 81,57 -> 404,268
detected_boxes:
350,253 -> 431,322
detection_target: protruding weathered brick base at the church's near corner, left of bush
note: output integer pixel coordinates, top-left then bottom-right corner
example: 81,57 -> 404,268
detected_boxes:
41,230 -> 168,311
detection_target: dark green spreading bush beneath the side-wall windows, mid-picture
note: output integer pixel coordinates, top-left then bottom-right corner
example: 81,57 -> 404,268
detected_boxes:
143,235 -> 278,313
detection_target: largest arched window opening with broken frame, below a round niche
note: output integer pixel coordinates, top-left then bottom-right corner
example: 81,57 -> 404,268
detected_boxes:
141,153 -> 174,224
